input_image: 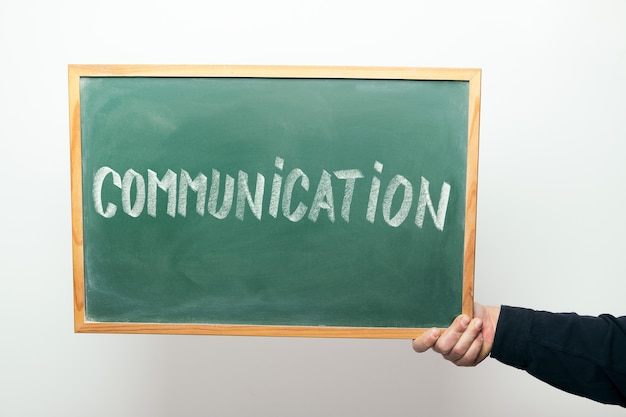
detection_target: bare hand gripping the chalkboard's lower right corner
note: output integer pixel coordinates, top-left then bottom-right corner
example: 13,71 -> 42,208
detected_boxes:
413,303 -> 500,366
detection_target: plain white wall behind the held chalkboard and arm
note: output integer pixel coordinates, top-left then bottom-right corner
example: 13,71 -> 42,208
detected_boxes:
0,0 -> 626,417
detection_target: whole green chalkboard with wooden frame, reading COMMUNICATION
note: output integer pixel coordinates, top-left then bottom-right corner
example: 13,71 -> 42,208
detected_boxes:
68,65 -> 481,338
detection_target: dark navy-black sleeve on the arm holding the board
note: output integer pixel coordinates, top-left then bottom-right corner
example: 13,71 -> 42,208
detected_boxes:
491,306 -> 626,407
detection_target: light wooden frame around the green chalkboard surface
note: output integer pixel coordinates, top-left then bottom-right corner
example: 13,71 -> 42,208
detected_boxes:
68,65 -> 481,338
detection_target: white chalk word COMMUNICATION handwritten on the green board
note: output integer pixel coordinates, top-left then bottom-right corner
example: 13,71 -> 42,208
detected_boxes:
92,157 -> 451,231
